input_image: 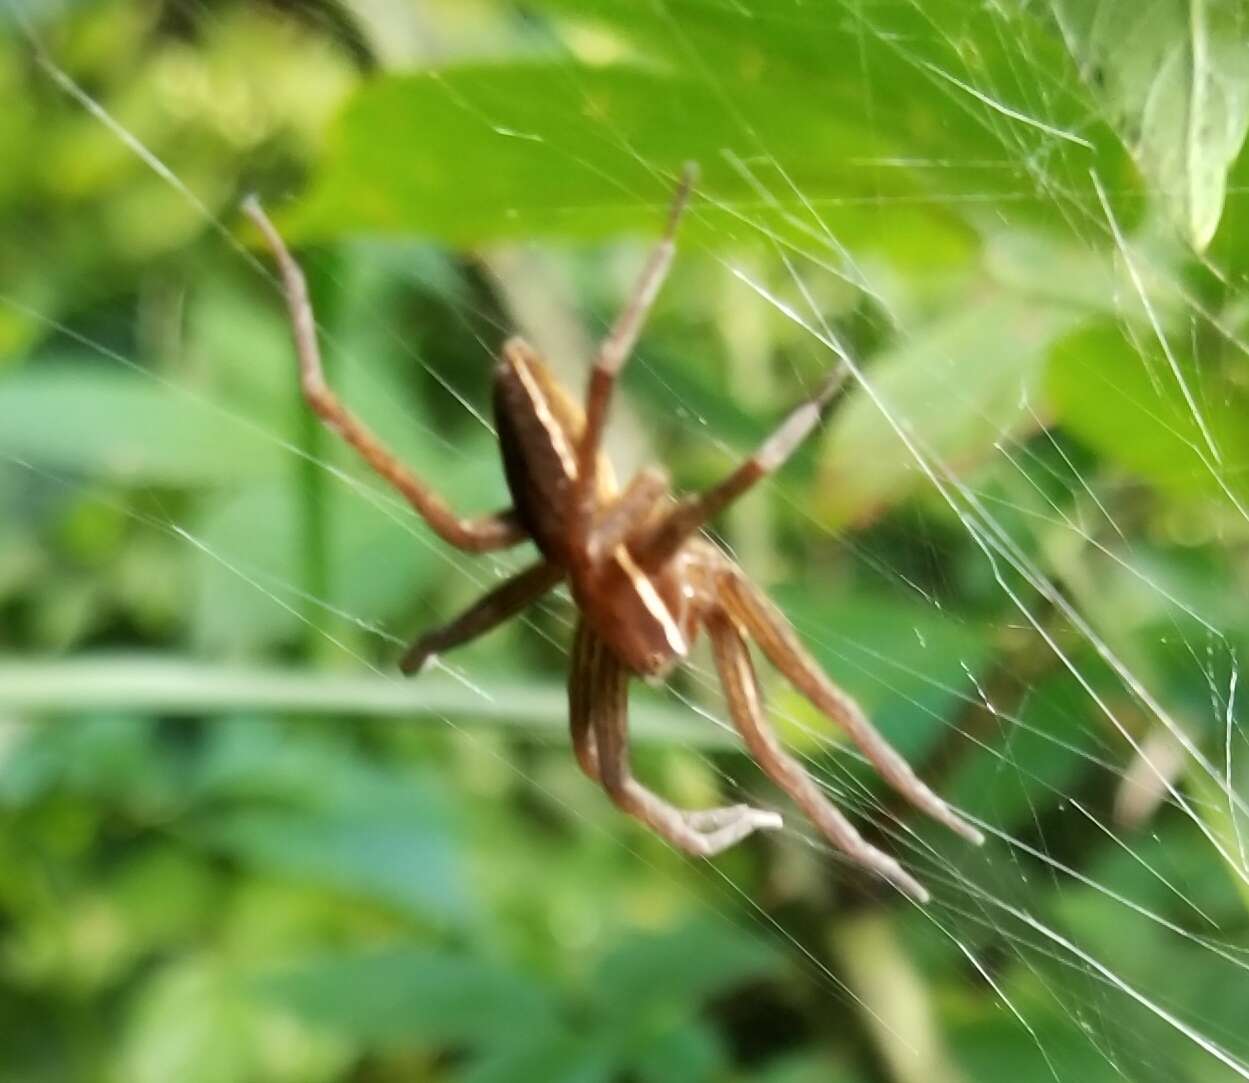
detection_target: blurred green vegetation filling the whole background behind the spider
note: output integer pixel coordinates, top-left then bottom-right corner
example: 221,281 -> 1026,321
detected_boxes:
0,0 -> 1249,1083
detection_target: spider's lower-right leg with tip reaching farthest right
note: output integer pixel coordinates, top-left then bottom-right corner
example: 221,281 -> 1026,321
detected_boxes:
718,558 -> 984,846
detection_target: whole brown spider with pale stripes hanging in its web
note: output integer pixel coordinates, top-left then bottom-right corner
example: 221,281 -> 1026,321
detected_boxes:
244,166 -> 983,902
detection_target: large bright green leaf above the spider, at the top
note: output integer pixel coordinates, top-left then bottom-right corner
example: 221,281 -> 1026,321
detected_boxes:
295,0 -> 1130,249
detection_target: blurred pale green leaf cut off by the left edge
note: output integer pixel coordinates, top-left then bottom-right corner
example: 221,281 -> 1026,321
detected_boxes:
0,361 -> 279,485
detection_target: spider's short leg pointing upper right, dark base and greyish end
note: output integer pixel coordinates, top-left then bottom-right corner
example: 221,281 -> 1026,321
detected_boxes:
637,366 -> 846,571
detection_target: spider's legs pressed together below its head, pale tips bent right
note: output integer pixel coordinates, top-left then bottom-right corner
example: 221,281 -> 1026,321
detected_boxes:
568,622 -> 781,857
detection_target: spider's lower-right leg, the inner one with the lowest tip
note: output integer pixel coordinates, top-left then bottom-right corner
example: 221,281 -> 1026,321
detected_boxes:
707,611 -> 929,903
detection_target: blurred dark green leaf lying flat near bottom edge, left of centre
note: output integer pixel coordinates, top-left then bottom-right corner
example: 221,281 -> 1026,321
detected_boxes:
252,947 -> 561,1049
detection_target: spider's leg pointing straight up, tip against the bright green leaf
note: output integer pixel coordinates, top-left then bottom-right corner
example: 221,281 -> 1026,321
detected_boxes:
571,162 -> 698,559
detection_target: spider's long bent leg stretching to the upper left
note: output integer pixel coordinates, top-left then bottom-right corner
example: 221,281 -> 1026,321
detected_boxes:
242,196 -> 526,552
